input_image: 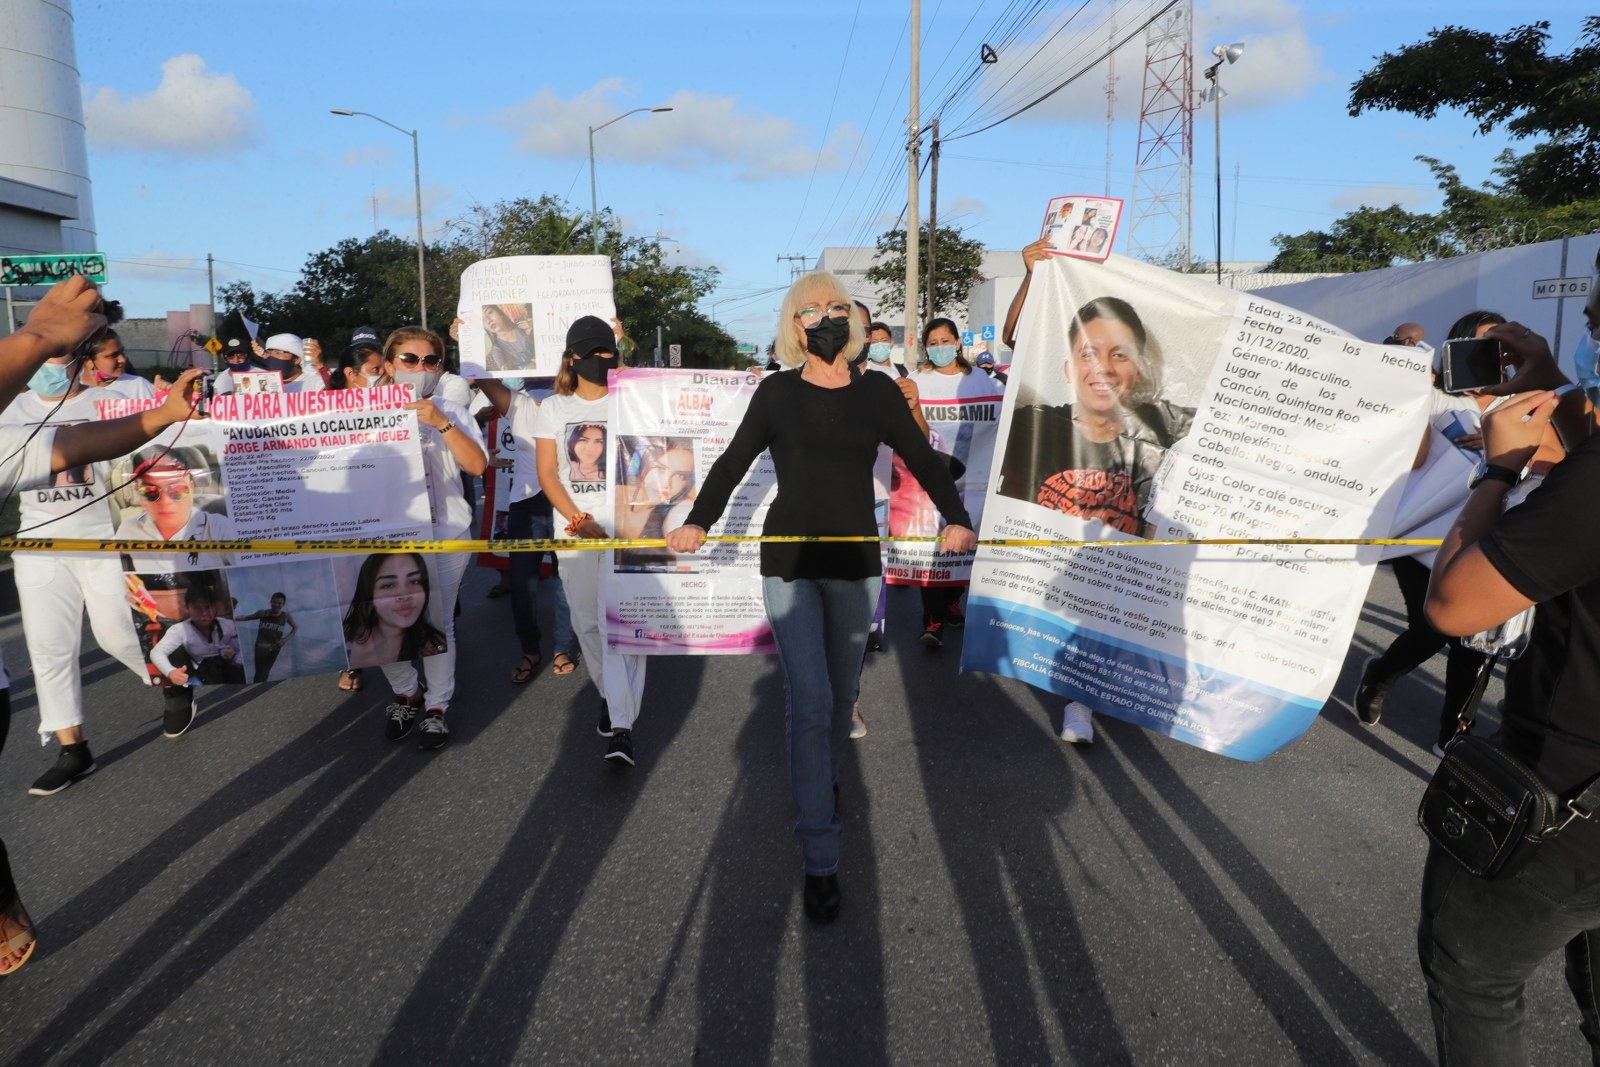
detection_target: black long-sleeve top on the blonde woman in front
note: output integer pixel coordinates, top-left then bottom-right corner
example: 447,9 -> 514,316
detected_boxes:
685,368 -> 973,581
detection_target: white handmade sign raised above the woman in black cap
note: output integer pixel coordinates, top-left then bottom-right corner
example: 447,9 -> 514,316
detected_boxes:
456,256 -> 616,378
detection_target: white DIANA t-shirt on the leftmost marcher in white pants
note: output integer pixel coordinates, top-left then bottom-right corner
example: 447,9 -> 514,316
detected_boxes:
0,387 -> 117,558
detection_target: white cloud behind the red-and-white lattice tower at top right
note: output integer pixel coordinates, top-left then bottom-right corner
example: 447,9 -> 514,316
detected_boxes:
954,0 -> 1326,126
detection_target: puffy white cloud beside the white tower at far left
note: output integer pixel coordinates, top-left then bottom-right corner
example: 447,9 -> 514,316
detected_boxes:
83,53 -> 258,155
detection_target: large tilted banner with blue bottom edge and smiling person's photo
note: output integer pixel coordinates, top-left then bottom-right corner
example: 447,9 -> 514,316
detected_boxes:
962,256 -> 1430,760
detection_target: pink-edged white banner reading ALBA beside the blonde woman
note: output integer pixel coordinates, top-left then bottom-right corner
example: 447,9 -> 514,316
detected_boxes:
600,370 -> 778,656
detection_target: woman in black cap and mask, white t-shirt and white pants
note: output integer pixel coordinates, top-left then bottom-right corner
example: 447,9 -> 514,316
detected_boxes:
533,315 -> 646,766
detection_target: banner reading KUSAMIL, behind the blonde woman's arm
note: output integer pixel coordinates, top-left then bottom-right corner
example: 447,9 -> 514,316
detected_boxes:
883,370 -> 1005,585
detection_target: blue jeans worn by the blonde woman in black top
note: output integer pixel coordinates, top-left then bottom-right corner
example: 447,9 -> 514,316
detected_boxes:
762,577 -> 883,875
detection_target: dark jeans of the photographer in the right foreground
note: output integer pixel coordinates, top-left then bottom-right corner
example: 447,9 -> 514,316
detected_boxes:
1416,845 -> 1600,1067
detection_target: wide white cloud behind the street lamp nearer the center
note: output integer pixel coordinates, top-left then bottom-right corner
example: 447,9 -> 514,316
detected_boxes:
494,78 -> 861,181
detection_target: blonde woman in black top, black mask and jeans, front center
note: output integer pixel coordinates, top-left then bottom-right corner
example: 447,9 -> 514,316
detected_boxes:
667,272 -> 978,921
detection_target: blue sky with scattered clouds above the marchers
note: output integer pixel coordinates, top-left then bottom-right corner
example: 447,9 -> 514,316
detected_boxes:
74,0 -> 1581,342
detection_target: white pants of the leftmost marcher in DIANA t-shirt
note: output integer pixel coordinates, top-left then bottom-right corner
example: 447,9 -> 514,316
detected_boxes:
14,552 -> 150,744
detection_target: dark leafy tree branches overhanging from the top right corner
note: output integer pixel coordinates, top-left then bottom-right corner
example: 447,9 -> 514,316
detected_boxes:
1349,14 -> 1600,206
